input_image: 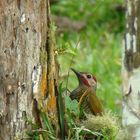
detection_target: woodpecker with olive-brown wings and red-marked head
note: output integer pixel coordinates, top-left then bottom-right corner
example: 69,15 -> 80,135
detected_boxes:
70,68 -> 103,115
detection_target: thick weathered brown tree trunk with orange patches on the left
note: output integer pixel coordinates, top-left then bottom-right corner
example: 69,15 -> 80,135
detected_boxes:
0,0 -> 56,140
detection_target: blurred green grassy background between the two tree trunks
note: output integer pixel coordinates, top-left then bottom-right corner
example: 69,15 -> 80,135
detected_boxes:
51,0 -> 125,115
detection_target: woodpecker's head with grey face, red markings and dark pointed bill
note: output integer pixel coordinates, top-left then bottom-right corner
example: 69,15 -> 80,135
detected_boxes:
71,68 -> 97,90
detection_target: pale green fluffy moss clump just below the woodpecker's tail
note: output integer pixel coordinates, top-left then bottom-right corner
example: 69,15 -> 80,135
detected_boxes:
82,112 -> 120,139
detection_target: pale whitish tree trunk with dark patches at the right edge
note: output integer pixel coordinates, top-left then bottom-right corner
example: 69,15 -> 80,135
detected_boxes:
122,0 -> 140,140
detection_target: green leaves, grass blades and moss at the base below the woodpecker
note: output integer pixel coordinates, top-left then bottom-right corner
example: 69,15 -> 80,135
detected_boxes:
26,85 -> 119,140
